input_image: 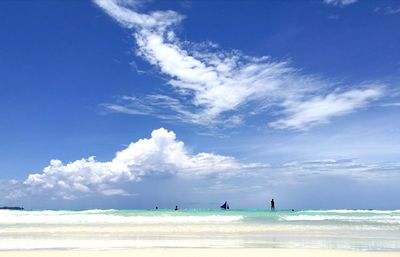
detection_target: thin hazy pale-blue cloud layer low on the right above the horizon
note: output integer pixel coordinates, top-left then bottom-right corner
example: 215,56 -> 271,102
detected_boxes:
195,159 -> 400,195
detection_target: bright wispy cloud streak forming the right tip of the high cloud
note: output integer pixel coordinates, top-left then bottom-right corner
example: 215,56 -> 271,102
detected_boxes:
270,87 -> 383,129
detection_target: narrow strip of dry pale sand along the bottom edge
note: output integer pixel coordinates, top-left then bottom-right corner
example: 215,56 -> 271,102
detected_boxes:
0,248 -> 400,257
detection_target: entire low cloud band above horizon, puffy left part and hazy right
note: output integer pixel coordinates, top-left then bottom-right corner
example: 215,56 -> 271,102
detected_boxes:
0,128 -> 400,201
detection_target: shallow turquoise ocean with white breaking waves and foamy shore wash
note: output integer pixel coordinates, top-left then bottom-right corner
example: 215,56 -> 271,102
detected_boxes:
0,209 -> 400,251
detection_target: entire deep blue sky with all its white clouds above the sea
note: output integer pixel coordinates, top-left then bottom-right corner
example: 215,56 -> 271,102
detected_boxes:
0,0 -> 400,208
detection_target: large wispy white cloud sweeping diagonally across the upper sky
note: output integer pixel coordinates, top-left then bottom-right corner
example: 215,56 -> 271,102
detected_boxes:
94,0 -> 385,130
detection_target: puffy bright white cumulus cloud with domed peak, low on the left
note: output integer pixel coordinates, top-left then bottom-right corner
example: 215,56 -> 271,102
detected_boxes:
24,128 -> 263,199
